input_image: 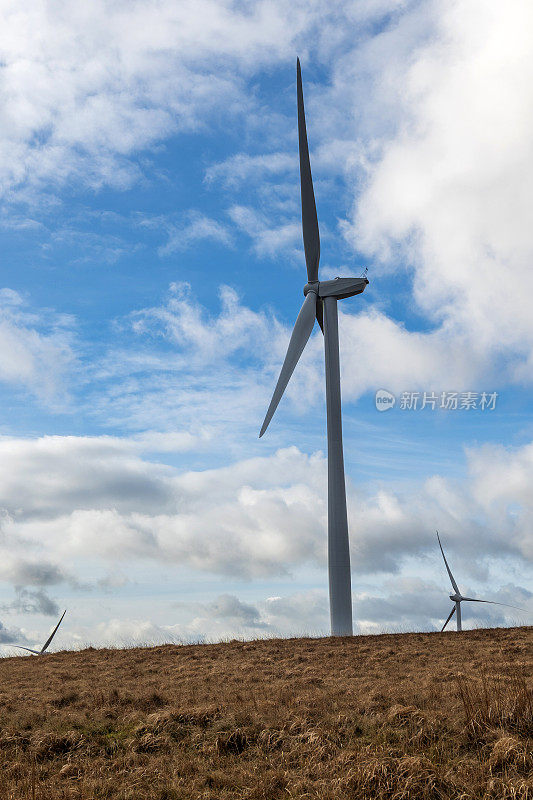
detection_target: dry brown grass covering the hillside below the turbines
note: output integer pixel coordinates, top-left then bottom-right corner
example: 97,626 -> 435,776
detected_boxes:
0,628 -> 533,800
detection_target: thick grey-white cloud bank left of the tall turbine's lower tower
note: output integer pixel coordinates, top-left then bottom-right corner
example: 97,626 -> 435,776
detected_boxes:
0,437 -> 324,585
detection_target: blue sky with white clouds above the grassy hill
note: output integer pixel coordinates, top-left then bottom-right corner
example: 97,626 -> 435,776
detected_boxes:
0,0 -> 533,655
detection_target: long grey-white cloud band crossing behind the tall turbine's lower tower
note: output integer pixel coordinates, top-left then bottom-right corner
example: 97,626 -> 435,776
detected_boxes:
0,437 -> 533,600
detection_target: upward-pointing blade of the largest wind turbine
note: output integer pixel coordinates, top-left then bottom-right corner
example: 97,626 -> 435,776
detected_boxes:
296,58 -> 320,283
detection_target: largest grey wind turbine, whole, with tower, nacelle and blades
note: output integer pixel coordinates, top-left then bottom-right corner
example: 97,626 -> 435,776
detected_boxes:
259,59 -> 368,636
